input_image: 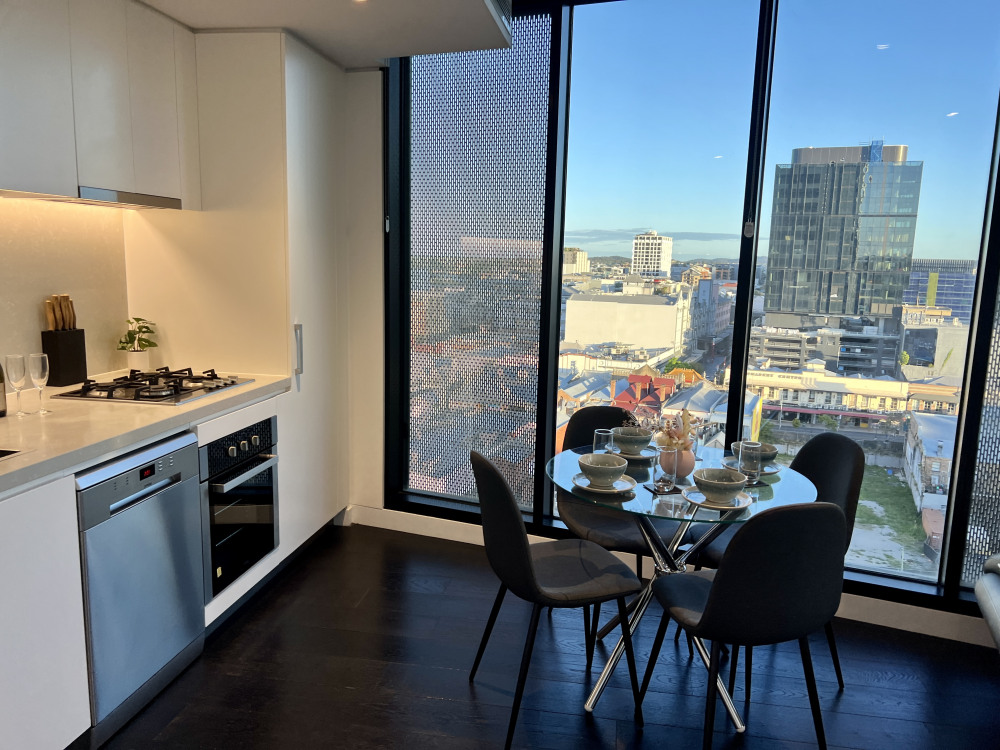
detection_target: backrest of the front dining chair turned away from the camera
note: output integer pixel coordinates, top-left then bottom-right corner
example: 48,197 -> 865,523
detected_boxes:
696,503 -> 846,646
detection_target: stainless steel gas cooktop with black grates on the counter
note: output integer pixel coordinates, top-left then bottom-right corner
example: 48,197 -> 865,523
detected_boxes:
54,367 -> 253,406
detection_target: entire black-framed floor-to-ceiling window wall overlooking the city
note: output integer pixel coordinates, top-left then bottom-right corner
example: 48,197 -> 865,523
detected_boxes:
387,0 -> 1000,604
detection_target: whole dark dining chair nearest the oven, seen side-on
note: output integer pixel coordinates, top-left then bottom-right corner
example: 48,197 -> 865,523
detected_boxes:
469,451 -> 642,748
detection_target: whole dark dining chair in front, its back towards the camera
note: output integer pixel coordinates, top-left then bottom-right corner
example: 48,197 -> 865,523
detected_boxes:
640,502 -> 847,750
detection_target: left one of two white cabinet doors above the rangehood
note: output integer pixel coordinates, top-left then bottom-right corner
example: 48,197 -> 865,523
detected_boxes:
70,0 -> 135,192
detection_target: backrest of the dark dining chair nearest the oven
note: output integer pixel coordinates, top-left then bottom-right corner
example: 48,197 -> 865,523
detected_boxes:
471,451 -> 539,601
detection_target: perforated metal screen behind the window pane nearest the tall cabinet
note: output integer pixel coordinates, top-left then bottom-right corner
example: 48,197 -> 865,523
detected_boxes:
409,16 -> 552,507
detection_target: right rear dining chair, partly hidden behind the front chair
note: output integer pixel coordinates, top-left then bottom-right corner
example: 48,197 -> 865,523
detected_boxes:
694,432 -> 865,697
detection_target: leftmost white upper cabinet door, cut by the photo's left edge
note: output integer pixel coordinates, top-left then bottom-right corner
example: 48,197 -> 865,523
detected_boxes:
0,0 -> 77,196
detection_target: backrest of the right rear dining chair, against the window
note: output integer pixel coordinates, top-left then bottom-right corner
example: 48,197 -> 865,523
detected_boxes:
791,432 -> 865,551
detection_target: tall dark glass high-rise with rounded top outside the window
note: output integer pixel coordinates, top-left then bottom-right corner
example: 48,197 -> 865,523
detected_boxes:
764,141 -> 923,327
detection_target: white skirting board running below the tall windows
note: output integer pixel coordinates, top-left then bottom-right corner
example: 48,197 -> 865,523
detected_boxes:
344,505 -> 994,647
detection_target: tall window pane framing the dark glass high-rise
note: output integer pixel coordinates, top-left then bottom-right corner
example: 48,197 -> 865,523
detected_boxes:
746,0 -> 1000,582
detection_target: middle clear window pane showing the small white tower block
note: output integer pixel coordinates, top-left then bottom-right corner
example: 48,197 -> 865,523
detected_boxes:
556,0 -> 758,458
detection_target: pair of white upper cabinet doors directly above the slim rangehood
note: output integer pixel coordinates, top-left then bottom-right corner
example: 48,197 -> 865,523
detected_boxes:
70,0 -> 181,203
